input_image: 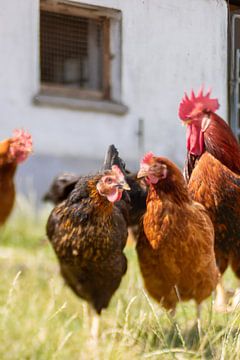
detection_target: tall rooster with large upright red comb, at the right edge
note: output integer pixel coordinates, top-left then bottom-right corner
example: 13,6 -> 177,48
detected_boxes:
179,89 -> 240,310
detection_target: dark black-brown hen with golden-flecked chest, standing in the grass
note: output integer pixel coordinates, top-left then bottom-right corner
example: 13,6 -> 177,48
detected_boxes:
47,165 -> 129,337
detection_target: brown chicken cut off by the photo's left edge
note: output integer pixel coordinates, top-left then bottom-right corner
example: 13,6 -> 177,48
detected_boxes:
0,130 -> 32,225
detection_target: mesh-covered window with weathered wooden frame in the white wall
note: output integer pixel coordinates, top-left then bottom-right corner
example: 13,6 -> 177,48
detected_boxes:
36,0 -> 126,112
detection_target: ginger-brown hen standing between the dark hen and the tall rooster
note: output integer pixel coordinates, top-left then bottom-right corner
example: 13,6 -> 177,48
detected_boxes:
137,153 -> 218,314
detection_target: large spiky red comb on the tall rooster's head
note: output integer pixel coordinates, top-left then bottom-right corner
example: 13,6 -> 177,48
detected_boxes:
178,86 -> 220,120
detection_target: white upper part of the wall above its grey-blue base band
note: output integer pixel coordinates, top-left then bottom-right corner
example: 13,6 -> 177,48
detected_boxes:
0,0 -> 227,163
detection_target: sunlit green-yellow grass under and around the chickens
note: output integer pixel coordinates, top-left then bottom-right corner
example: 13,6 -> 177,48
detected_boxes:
0,198 -> 240,360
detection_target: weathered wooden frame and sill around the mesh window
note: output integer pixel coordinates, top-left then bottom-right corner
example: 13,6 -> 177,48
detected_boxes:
34,0 -> 128,114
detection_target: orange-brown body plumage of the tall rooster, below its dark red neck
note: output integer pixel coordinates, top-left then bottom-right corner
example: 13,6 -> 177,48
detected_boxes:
188,152 -> 240,278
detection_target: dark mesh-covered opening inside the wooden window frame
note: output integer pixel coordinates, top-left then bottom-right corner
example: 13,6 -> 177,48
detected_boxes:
40,10 -> 103,90
